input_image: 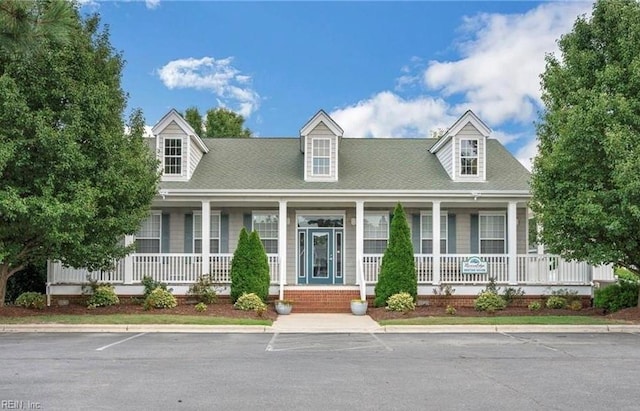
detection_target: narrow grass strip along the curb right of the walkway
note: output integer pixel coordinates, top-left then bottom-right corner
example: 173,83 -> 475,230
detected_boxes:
380,315 -> 621,325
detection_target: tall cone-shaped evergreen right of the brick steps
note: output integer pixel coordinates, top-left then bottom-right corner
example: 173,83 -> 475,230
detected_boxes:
374,203 -> 418,307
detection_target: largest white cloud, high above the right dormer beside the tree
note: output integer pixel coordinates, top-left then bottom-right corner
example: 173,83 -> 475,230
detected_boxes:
424,2 -> 591,124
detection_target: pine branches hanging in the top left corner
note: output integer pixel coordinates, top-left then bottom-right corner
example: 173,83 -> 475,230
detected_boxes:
0,0 -> 75,53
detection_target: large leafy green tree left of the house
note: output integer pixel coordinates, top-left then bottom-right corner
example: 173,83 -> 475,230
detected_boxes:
0,1 -> 158,304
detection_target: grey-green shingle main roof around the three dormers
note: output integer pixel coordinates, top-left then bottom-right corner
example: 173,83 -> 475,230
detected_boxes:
161,138 -> 529,191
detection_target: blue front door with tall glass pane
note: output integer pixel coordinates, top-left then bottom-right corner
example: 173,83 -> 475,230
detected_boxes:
307,228 -> 335,284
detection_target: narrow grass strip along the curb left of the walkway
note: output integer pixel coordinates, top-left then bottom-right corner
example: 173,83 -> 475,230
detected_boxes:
0,314 -> 272,325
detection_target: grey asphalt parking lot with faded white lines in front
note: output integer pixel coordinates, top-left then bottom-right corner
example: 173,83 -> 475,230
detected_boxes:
0,333 -> 640,410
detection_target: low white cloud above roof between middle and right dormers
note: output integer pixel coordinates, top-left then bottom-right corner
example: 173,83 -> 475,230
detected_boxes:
330,91 -> 455,138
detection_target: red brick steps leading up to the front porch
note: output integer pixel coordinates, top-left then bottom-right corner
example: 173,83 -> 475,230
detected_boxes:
284,289 -> 360,313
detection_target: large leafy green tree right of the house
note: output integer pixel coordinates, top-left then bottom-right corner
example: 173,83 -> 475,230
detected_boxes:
531,0 -> 640,303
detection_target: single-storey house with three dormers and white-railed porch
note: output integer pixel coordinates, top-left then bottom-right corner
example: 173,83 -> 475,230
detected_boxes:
48,110 -> 613,311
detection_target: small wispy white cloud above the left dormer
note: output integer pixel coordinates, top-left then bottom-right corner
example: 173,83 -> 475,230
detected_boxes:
157,57 -> 260,117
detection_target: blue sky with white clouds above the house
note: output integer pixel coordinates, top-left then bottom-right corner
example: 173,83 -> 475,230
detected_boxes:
81,0 -> 592,168
